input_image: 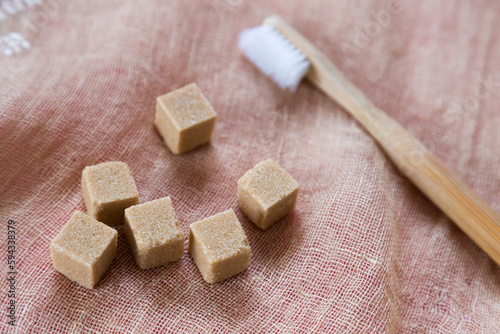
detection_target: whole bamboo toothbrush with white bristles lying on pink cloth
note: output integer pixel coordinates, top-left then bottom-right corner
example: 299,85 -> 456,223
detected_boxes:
238,16 -> 500,265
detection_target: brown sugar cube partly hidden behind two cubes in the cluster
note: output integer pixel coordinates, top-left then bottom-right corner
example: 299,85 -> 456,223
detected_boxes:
82,161 -> 139,226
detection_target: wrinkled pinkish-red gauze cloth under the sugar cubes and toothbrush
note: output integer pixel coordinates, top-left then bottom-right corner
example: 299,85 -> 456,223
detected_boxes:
0,0 -> 500,333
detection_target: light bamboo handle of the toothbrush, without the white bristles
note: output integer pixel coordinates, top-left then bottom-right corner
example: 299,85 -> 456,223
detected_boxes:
264,16 -> 500,265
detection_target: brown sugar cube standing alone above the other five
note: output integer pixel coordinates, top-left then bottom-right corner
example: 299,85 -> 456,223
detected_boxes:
155,83 -> 217,154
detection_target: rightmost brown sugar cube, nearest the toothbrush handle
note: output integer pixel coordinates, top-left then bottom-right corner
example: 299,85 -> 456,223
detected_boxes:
238,159 -> 299,230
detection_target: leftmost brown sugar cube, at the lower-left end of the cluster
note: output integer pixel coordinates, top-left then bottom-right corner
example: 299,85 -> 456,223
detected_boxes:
50,211 -> 118,289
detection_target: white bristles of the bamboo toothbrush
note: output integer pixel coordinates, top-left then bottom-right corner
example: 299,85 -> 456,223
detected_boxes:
238,25 -> 310,91
